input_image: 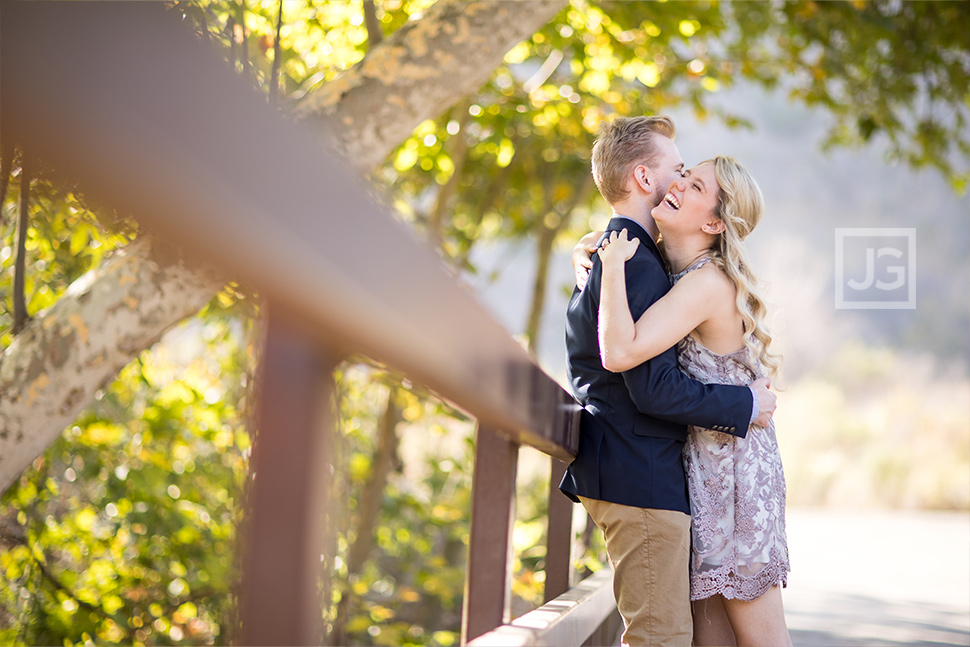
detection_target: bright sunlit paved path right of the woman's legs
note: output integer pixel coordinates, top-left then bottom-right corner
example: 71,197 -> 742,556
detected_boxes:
784,508 -> 970,647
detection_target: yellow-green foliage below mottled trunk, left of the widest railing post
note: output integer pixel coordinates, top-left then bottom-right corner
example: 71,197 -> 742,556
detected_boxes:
0,313 -> 251,644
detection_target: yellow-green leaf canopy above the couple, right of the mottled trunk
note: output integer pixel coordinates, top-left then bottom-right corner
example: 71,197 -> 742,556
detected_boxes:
378,0 -> 970,271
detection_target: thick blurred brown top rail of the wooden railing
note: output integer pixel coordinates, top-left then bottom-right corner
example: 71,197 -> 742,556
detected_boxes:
0,2 -> 579,460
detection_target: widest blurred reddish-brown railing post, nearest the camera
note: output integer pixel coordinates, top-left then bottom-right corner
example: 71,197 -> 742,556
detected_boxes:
241,312 -> 334,645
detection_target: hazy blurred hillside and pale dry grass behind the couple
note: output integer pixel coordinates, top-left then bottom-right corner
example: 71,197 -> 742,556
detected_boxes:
476,84 -> 970,510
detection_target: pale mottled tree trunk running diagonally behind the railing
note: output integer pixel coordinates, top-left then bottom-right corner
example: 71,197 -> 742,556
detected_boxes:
0,0 -> 566,492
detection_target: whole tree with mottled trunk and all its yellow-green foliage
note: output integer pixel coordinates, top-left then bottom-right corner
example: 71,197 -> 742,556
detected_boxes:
0,0 -> 970,644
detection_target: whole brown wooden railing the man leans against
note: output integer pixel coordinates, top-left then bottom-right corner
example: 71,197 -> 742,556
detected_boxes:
0,3 -> 617,645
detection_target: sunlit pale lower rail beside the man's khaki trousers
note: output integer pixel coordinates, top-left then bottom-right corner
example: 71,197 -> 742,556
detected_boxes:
468,568 -> 616,647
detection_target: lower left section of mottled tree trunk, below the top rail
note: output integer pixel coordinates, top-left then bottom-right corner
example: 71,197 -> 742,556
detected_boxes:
0,237 -> 226,492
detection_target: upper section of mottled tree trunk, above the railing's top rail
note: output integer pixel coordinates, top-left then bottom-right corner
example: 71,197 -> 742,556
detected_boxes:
294,0 -> 566,171
